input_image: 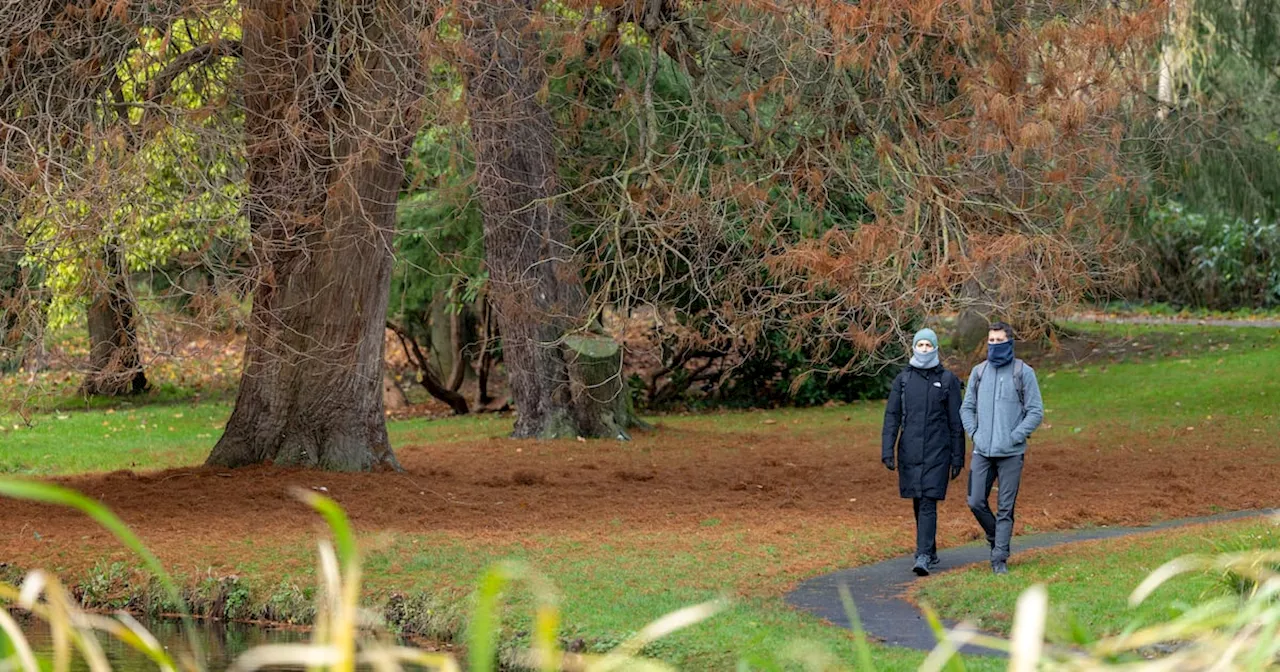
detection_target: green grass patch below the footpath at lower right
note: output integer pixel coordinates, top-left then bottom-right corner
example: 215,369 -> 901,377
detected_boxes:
914,520 -> 1280,640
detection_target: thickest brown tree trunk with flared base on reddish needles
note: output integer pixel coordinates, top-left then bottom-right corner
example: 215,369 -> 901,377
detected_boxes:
209,0 -> 422,470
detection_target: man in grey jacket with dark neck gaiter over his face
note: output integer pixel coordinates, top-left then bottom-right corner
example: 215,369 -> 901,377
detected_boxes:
960,323 -> 1044,573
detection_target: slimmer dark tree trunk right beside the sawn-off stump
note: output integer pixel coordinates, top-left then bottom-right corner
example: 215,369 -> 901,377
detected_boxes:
463,0 -> 631,438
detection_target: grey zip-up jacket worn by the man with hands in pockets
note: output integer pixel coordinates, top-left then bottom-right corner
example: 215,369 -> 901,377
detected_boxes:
960,362 -> 1044,457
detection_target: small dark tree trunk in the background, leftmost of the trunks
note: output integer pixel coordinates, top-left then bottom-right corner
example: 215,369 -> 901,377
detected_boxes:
81,243 -> 147,397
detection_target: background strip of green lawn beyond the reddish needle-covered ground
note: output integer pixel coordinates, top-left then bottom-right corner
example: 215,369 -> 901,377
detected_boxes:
10,324 -> 1280,476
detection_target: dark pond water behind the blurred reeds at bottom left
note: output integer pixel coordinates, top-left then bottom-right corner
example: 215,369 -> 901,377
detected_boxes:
15,614 -> 310,672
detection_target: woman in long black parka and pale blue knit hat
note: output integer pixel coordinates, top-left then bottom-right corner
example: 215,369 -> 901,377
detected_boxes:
881,329 -> 964,576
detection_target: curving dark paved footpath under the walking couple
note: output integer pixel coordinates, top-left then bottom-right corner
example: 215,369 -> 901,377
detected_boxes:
786,509 -> 1280,655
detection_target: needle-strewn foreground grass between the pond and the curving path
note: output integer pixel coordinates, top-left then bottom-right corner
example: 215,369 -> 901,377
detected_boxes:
49,530 -> 1004,671
